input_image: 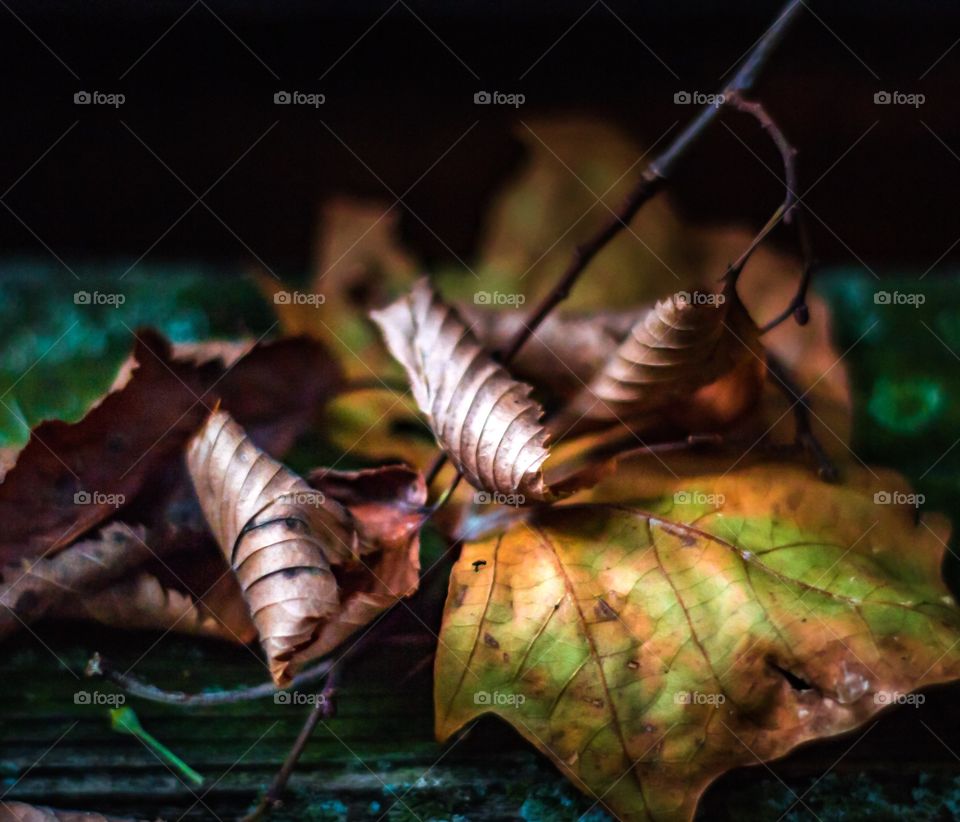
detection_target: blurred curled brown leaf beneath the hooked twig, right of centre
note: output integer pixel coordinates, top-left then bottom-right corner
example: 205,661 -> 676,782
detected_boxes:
570,288 -> 764,430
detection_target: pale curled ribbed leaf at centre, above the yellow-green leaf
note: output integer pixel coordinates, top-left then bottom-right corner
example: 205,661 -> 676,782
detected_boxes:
371,279 -> 551,500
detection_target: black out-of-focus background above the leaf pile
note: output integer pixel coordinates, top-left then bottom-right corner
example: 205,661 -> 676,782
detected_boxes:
0,0 -> 960,275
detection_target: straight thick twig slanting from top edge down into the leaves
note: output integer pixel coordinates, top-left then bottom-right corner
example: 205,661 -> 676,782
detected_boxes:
499,0 -> 803,364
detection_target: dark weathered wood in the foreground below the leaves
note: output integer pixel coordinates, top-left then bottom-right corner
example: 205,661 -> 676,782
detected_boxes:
0,625 -> 960,822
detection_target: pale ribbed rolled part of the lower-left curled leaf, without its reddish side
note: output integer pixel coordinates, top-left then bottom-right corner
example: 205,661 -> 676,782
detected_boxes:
187,411 -> 358,685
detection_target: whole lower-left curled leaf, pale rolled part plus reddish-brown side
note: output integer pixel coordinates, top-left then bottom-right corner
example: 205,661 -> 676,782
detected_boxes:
187,412 -> 427,685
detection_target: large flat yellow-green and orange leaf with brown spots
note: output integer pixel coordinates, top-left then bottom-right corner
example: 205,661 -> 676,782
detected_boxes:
435,466 -> 960,820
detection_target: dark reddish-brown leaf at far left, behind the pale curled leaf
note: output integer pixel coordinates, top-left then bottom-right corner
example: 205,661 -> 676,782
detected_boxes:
0,331 -> 340,562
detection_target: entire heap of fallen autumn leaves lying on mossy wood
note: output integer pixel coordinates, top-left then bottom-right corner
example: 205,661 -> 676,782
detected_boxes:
0,114 -> 960,820
